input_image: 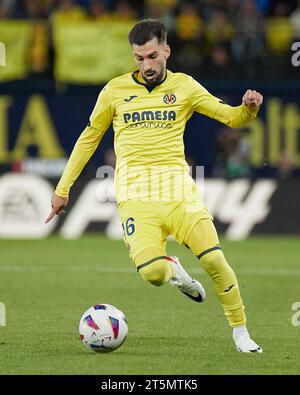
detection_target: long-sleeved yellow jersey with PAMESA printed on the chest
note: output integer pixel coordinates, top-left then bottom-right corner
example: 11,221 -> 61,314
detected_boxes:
55,70 -> 258,201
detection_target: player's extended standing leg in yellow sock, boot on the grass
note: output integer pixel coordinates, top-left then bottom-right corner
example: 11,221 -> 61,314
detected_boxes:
185,218 -> 262,352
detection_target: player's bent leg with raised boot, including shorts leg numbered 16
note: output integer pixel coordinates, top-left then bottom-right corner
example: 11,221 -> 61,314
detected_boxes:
119,200 -> 205,302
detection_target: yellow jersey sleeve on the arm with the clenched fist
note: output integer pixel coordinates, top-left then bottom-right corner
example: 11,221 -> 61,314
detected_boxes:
190,78 -> 258,128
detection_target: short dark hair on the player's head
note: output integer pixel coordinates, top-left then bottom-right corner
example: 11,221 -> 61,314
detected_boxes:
128,19 -> 167,45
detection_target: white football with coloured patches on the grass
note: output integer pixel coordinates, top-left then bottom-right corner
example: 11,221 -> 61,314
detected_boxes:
79,304 -> 128,352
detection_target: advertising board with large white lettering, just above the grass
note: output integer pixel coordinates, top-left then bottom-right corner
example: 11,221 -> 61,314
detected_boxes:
0,173 -> 300,240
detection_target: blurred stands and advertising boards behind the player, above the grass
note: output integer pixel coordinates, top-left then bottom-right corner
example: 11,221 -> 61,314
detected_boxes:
0,0 -> 300,239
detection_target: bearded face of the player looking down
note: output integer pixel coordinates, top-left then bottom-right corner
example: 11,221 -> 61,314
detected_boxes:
132,37 -> 171,85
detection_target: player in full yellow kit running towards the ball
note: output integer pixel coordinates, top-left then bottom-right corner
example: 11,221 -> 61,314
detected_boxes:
46,20 -> 263,353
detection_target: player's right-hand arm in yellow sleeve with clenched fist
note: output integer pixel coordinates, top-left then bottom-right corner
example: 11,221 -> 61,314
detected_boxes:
190,80 -> 263,128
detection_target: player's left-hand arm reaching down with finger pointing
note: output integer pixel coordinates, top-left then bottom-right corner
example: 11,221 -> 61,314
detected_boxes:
45,86 -> 114,223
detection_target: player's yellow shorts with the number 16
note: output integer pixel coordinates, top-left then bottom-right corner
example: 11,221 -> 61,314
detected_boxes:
118,194 -> 212,261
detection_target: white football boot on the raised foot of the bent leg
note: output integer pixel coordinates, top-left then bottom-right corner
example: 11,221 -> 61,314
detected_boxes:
168,256 -> 206,303
